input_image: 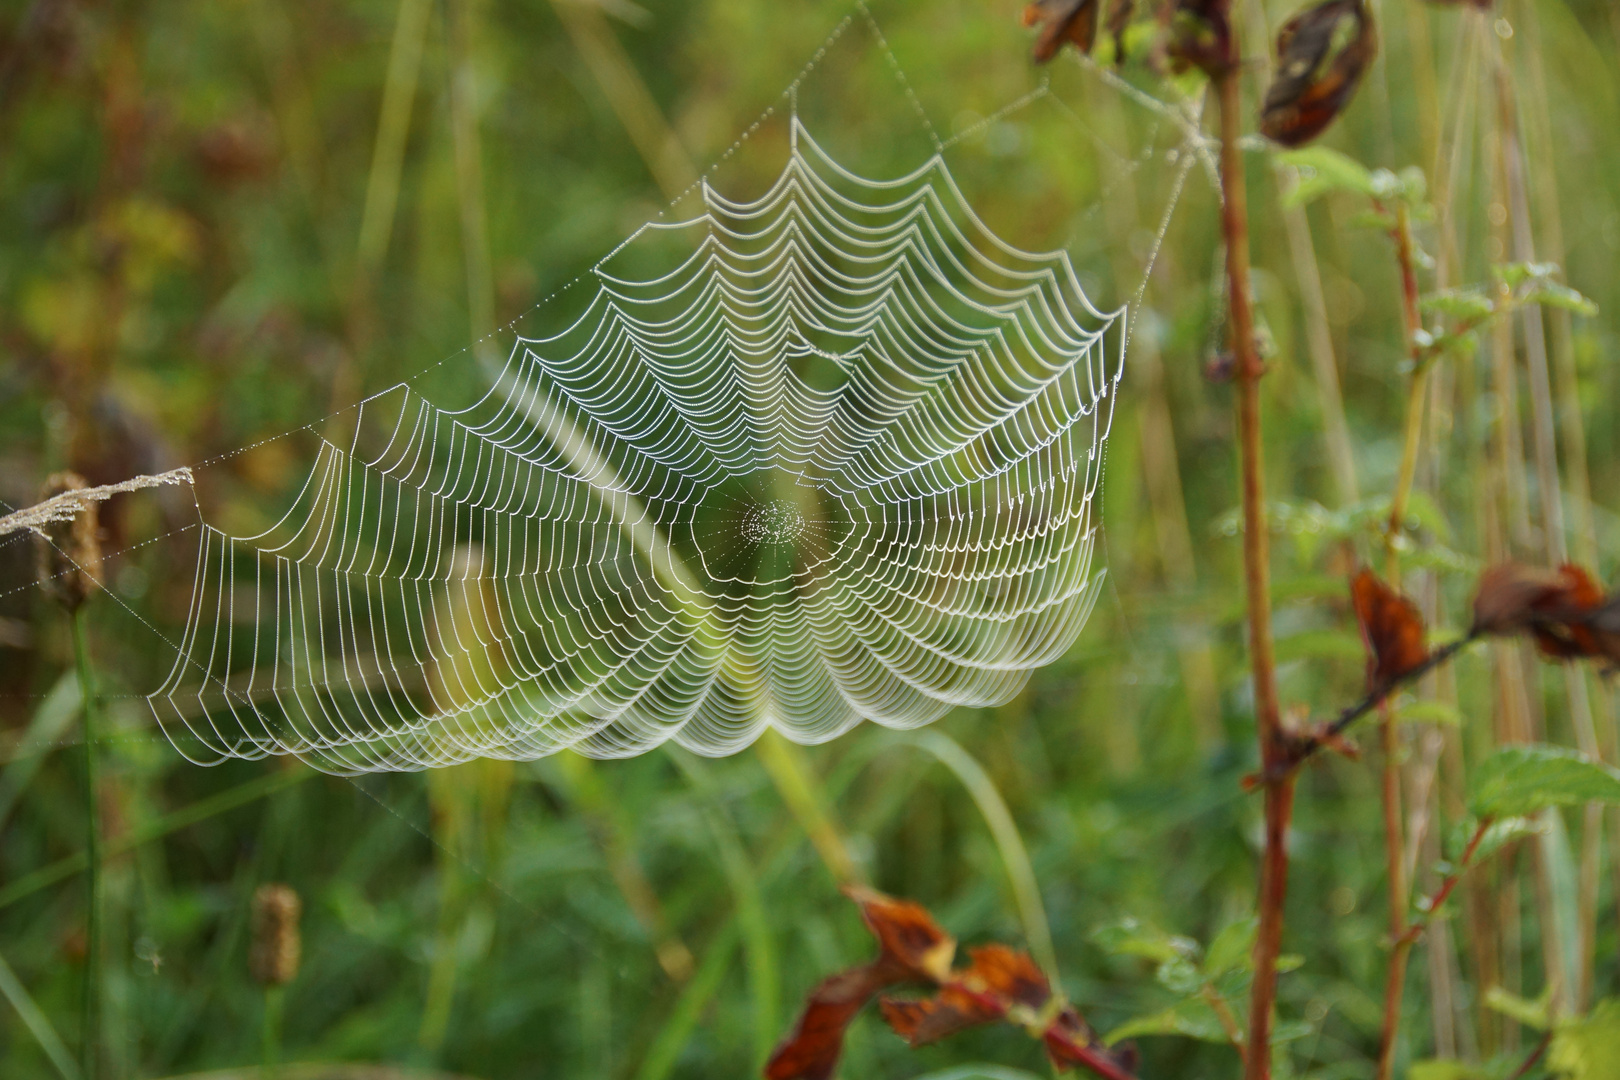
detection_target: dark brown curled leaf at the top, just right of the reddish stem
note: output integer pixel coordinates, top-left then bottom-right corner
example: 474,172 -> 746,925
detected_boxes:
1260,0 -> 1379,146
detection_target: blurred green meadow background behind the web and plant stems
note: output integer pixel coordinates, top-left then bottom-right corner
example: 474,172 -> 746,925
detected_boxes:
0,0 -> 1620,1080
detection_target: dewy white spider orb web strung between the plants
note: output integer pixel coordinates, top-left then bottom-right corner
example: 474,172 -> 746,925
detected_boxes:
151,117 -> 1126,772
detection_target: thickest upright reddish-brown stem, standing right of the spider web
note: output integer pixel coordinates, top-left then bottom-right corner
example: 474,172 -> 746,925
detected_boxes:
1215,57 -> 1294,1080
